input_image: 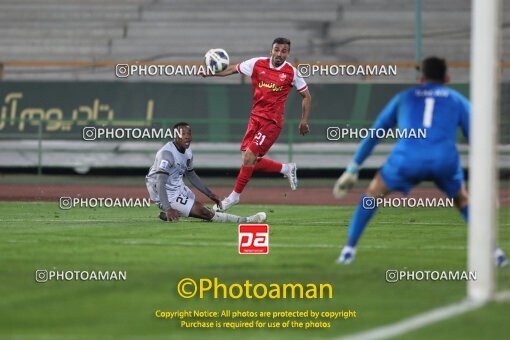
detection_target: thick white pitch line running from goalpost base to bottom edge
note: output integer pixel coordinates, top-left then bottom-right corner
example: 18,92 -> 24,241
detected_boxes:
338,300 -> 484,340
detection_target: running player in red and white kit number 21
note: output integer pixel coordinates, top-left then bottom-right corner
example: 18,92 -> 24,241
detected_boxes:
206,38 -> 312,211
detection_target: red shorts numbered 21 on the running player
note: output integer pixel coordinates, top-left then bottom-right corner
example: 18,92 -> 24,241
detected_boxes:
241,115 -> 282,157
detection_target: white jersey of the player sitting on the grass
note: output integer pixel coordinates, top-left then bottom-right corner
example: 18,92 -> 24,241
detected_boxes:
146,142 -> 193,201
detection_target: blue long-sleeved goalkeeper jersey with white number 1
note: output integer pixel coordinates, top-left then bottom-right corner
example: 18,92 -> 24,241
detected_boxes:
354,84 -> 471,165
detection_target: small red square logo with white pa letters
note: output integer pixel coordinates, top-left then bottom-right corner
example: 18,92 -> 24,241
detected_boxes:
239,224 -> 269,254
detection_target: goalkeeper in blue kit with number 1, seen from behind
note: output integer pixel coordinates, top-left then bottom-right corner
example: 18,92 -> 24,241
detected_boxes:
333,57 -> 507,266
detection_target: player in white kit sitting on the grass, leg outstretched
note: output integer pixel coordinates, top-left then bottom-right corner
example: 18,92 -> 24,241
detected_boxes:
146,122 -> 266,223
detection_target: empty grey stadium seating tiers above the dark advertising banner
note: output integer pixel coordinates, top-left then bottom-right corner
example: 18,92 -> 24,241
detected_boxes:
0,0 -> 510,82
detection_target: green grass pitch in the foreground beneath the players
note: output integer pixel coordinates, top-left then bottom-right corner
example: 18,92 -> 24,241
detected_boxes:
0,202 -> 510,339
